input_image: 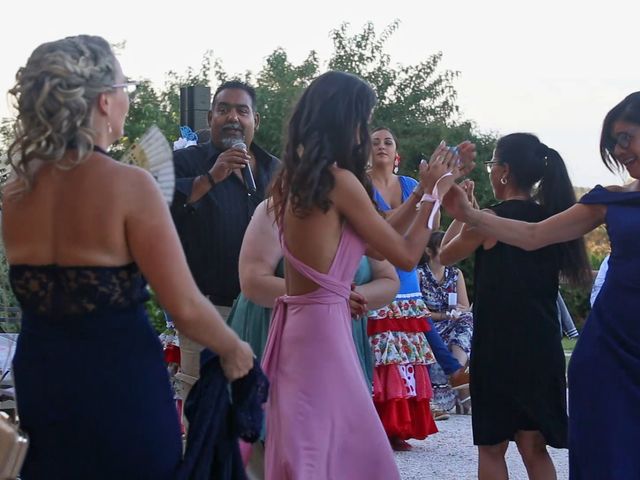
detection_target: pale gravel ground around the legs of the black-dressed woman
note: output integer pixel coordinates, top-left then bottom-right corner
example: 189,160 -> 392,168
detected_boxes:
395,415 -> 569,480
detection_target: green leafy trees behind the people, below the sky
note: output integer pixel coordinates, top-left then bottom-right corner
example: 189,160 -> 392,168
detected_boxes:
0,20 -> 604,331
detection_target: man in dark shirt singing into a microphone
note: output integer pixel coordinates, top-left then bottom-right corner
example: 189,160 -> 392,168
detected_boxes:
171,80 -> 279,397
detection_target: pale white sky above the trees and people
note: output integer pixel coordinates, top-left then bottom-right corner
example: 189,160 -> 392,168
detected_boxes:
0,0 -> 640,187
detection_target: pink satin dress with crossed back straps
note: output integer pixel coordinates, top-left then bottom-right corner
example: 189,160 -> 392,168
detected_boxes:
262,223 -> 400,480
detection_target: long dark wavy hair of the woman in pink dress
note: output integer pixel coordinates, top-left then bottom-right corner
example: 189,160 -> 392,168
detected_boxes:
272,71 -> 376,222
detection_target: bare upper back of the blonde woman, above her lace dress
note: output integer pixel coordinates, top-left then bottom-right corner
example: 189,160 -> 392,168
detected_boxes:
3,152 -> 145,266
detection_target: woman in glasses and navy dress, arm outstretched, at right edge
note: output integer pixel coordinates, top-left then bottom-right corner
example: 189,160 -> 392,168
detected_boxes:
445,92 -> 640,480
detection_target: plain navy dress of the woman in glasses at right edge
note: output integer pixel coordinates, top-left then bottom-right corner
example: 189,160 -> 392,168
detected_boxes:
569,185 -> 640,480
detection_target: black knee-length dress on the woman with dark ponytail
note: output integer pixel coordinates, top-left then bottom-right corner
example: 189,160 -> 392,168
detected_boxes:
470,200 -> 567,448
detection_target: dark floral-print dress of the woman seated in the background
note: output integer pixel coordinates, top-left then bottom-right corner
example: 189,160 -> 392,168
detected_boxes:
418,263 -> 473,411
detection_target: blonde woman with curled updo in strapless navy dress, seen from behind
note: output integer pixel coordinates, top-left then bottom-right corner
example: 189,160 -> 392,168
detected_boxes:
2,35 -> 253,480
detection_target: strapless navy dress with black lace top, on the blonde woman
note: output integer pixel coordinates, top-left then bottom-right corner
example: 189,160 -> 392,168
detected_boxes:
10,264 -> 182,480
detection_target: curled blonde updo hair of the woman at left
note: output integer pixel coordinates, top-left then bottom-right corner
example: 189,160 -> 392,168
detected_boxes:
8,35 -> 116,193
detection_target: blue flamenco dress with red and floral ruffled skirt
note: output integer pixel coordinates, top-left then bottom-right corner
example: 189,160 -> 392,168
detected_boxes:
367,176 -> 438,440
